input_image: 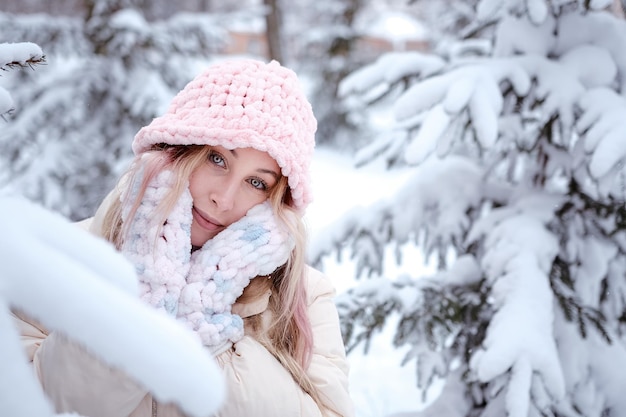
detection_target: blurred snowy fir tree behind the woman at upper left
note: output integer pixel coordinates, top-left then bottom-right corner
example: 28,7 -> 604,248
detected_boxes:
0,0 -> 226,219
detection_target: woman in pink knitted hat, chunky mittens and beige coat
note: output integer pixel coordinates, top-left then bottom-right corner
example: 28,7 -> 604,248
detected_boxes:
14,60 -> 353,417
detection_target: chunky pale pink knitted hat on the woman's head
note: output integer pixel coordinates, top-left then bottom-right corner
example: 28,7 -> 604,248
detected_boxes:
133,59 -> 317,211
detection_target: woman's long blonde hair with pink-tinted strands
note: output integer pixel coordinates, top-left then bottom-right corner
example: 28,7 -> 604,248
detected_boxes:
102,144 -> 328,414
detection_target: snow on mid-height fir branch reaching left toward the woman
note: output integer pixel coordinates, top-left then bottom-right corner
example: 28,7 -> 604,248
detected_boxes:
309,156 -> 492,276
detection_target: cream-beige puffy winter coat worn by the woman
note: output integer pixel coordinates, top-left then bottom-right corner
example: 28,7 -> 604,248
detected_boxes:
15,196 -> 354,417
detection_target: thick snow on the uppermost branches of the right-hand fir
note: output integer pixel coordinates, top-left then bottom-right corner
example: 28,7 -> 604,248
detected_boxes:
339,7 -> 626,195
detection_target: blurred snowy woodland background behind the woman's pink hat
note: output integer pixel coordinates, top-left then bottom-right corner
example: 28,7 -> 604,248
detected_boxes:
0,0 -> 438,219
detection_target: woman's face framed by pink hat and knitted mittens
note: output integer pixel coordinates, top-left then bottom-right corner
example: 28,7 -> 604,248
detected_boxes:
189,146 -> 280,246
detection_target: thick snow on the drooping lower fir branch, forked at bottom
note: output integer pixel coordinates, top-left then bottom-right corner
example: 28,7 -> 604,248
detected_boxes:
468,193 -> 565,417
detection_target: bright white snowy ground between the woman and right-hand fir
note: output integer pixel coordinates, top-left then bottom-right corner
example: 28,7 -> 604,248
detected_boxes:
306,148 -> 438,417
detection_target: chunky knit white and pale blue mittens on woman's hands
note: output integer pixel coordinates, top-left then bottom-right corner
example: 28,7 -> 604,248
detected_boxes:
122,171 -> 294,353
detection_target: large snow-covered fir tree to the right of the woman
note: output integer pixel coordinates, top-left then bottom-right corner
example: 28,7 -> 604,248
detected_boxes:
312,0 -> 626,417
